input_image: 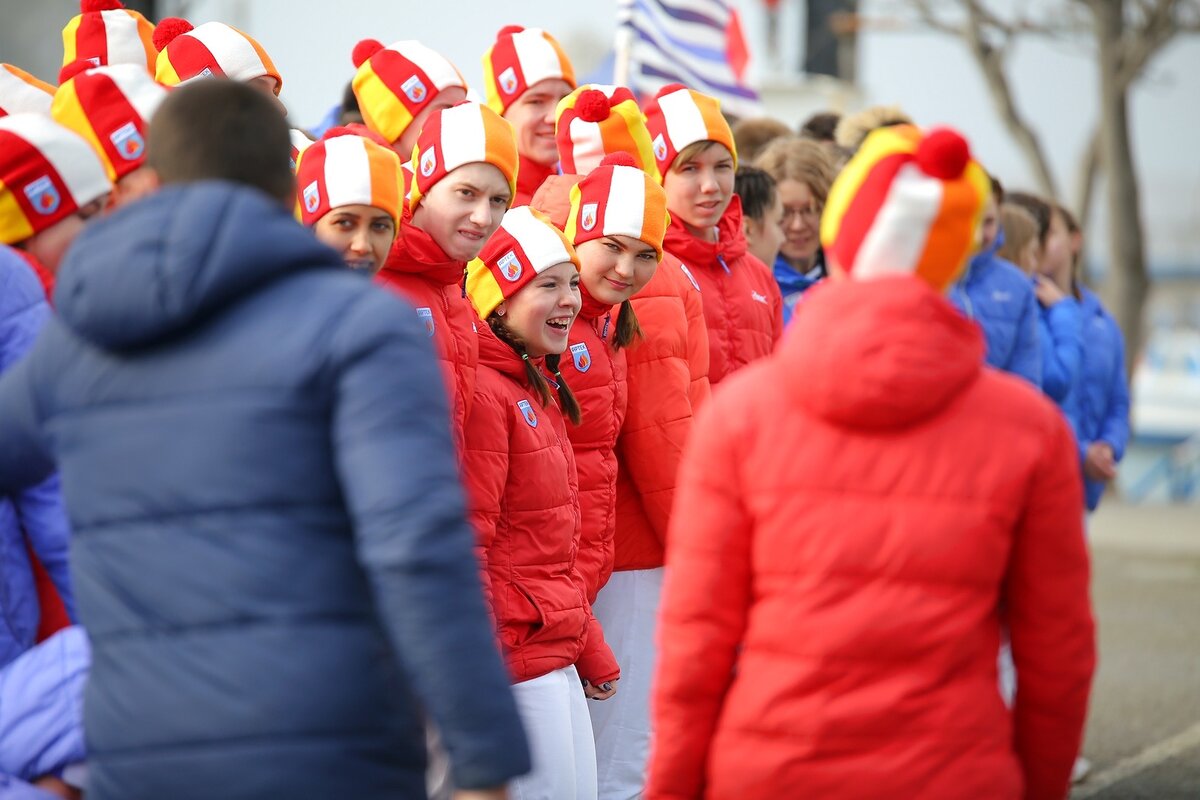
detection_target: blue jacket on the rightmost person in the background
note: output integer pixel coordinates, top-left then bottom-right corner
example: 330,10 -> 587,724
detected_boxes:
1062,289 -> 1129,511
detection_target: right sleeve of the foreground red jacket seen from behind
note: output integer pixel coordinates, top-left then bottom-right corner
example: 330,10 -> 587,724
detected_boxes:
1004,414 -> 1096,800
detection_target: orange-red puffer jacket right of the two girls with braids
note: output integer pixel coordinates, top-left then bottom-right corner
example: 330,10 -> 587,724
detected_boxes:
614,253 -> 709,571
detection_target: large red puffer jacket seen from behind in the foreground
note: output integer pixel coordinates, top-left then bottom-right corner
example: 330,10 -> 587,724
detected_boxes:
647,277 -> 1094,800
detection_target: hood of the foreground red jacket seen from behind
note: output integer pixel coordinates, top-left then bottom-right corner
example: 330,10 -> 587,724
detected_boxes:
779,276 -> 984,429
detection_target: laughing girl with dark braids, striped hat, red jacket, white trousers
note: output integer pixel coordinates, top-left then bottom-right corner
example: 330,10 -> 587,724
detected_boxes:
463,206 -> 619,800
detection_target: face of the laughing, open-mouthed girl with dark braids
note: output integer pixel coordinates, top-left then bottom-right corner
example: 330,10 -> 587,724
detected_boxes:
496,261 -> 582,359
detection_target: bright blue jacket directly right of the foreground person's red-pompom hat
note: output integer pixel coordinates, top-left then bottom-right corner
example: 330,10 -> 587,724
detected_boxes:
949,233 -> 1042,389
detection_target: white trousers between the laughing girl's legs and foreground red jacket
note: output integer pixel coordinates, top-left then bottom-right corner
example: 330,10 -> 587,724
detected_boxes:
588,567 -> 662,800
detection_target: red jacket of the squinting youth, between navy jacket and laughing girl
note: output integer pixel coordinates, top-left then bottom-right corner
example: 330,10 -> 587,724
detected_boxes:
376,219 -> 479,451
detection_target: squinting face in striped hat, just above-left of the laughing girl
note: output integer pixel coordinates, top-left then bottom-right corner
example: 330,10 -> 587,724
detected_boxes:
413,162 -> 512,261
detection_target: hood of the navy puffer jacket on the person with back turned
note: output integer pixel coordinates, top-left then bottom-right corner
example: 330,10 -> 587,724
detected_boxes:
54,181 -> 338,350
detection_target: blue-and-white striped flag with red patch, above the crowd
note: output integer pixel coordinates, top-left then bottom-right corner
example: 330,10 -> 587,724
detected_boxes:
617,0 -> 762,116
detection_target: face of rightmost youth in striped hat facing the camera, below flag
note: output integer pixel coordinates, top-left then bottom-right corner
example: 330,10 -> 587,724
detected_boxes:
662,142 -> 733,241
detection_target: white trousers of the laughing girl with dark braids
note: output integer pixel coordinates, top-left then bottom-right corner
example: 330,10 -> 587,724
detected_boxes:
509,667 -> 596,800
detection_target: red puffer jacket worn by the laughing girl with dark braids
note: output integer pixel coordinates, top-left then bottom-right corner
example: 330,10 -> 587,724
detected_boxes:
463,325 -> 620,684
